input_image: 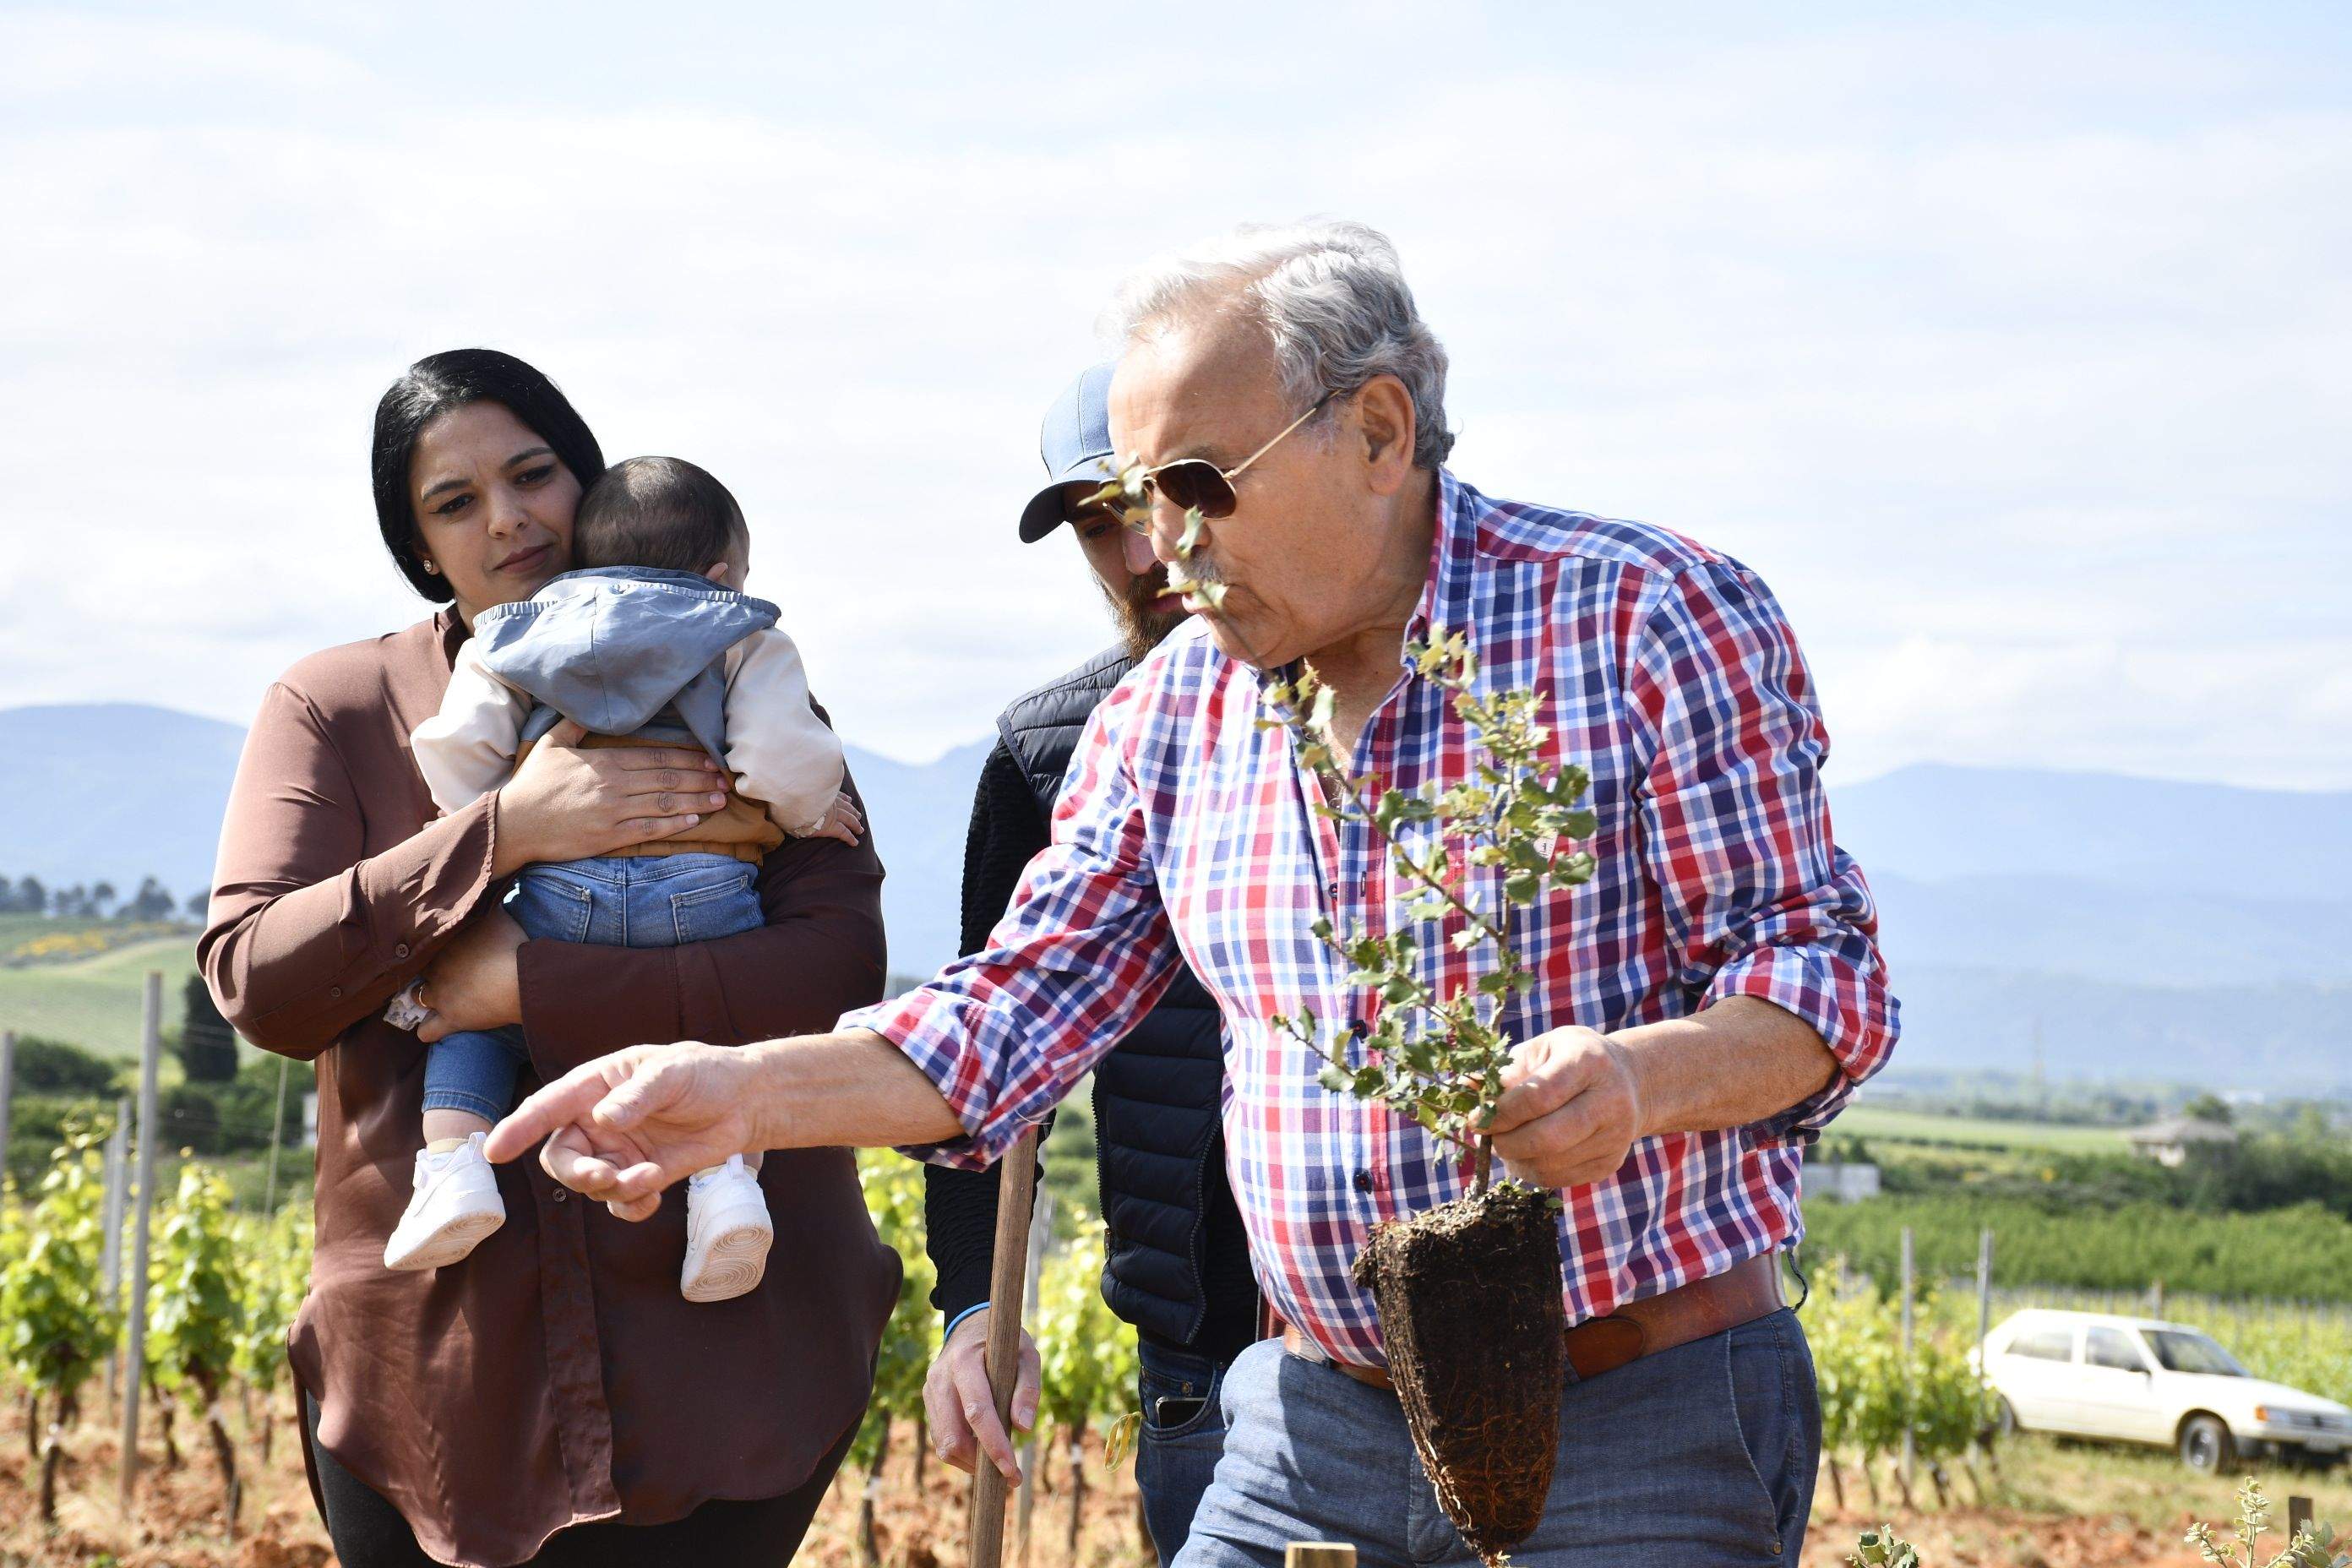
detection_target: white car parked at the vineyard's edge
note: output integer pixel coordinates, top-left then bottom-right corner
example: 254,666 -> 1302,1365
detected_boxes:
1983,1307 -> 2352,1474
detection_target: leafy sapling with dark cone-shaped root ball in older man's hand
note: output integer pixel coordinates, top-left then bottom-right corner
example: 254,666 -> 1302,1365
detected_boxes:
1096,463 -> 1597,1563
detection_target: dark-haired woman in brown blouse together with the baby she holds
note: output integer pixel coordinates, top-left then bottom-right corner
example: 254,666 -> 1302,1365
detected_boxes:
200,351 -> 896,1568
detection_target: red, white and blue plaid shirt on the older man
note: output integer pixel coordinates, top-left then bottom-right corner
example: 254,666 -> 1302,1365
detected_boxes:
842,475 -> 1898,1364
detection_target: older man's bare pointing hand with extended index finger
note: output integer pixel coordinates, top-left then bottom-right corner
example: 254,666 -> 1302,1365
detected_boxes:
485,1043 -> 769,1220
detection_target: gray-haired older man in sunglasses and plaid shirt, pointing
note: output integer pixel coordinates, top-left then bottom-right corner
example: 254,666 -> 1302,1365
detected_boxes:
494,223 -> 1898,1568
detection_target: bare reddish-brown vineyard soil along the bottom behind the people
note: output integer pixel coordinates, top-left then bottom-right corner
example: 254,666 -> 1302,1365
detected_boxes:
0,1399 -> 2352,1568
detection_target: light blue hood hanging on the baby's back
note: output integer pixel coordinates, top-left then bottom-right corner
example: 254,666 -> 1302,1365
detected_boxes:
473,567 -> 776,736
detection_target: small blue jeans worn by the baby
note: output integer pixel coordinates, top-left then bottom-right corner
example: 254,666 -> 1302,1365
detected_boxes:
426,856 -> 767,1121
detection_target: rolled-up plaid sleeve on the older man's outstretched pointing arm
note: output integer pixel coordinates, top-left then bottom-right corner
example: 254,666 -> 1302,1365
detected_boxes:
840,687 -> 1176,1168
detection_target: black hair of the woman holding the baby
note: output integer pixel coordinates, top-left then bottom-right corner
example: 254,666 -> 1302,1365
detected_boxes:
369,348 -> 604,604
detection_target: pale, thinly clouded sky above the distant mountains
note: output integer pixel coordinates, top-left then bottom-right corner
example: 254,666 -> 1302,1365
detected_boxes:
0,0 -> 2352,787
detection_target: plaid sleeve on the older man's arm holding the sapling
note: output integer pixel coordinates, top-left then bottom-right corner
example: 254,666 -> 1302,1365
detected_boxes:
1630,562 -> 1900,1142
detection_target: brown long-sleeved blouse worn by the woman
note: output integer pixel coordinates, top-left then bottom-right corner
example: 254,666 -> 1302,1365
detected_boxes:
198,611 -> 898,1568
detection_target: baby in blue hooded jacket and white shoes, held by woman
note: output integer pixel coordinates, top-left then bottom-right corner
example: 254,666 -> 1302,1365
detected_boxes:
384,459 -> 863,1303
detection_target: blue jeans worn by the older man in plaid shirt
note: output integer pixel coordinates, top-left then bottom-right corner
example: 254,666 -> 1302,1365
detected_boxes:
1176,1309 -> 1821,1568
